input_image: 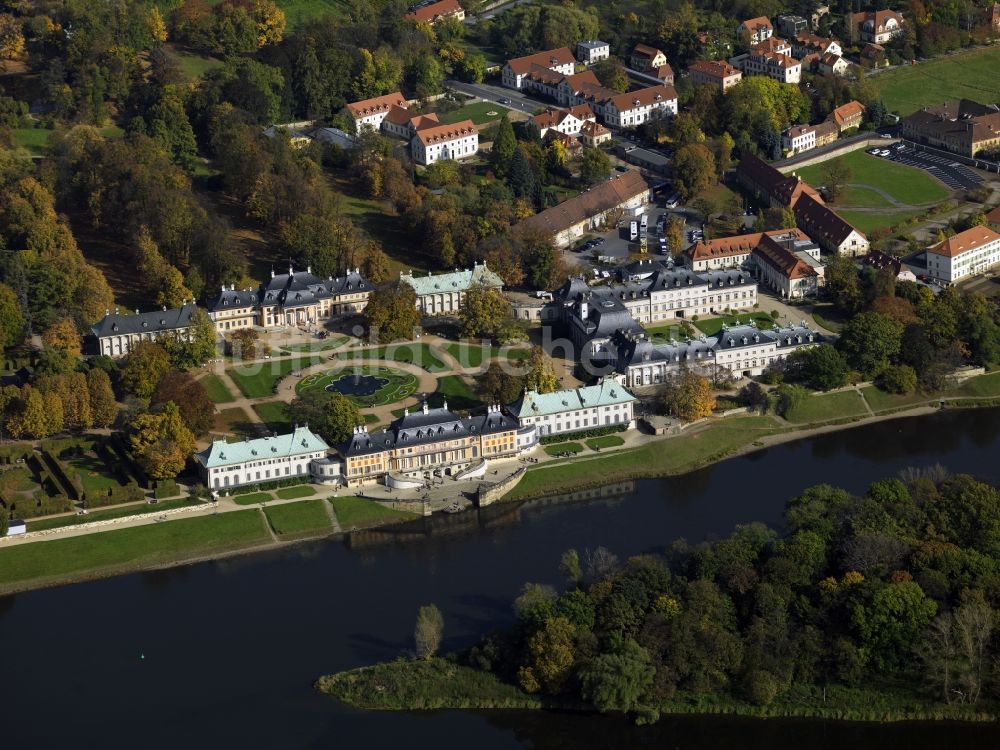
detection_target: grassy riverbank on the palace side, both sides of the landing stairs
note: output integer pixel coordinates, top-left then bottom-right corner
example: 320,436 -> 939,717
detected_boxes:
0,382 -> 1000,595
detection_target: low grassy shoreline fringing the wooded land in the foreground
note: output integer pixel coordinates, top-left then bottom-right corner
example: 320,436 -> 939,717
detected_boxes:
315,655 -> 998,724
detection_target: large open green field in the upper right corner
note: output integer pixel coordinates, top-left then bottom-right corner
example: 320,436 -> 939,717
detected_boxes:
871,47 -> 1000,117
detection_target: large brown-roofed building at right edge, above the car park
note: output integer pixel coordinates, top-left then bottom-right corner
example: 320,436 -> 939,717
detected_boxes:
900,99 -> 1000,157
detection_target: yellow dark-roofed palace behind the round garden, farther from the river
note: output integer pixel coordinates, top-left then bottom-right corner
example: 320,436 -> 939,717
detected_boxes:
206,267 -> 375,333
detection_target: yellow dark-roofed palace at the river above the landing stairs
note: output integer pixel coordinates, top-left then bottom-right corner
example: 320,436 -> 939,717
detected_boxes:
337,402 -> 531,488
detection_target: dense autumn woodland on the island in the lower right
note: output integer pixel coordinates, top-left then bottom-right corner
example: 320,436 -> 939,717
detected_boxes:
321,467 -> 1000,721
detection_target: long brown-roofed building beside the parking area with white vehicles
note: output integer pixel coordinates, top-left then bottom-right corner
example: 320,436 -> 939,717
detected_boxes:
517,171 -> 649,247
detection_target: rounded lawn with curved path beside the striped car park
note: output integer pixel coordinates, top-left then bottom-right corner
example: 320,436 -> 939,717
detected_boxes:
795,151 -> 951,207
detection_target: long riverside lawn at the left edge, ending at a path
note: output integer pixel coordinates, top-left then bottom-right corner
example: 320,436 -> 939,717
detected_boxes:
0,510 -> 267,586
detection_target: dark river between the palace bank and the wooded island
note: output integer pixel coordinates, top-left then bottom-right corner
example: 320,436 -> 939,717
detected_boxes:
0,409 -> 1000,750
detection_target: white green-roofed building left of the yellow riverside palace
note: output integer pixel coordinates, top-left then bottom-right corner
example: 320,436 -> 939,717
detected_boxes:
194,427 -> 331,491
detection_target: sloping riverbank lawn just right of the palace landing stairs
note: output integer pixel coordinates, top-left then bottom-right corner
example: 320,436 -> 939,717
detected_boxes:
507,417 -> 782,500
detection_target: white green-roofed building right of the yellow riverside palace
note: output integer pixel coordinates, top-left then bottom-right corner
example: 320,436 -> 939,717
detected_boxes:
507,378 -> 636,438
